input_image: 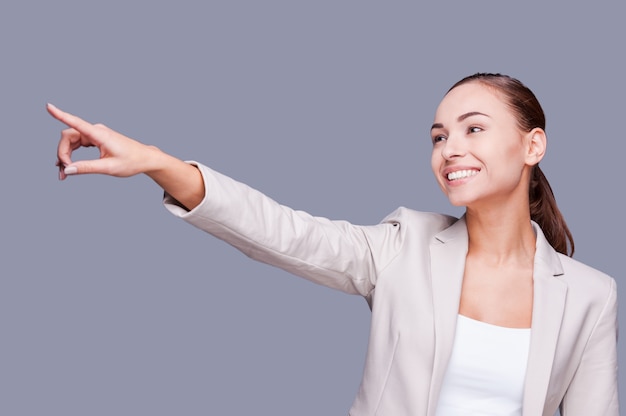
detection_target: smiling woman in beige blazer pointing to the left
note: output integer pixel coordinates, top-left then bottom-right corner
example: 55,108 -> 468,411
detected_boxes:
48,74 -> 618,416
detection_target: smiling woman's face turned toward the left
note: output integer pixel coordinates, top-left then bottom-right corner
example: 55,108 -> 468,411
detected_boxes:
431,82 -> 530,207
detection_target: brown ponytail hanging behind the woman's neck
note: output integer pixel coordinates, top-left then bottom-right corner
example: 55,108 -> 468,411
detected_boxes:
529,165 -> 574,257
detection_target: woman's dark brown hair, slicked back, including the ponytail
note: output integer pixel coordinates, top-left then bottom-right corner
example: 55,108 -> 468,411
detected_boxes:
448,73 -> 574,256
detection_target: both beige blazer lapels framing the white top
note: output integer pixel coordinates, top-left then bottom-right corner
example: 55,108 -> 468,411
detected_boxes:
429,216 -> 567,415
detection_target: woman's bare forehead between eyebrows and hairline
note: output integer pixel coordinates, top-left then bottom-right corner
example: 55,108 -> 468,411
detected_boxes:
435,82 -> 512,122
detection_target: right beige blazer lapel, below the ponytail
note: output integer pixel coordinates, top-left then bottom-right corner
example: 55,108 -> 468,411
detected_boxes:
523,223 -> 567,416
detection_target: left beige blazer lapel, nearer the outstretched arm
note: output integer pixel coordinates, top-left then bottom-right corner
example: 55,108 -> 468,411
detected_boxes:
428,216 -> 468,414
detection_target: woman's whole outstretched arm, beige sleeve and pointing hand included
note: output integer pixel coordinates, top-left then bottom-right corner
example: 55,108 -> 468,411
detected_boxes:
48,105 -> 403,296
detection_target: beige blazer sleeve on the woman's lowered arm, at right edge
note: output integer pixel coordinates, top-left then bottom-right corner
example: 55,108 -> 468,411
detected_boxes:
561,279 -> 619,416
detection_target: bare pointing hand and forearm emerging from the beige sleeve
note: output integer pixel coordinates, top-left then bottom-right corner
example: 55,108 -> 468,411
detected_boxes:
47,104 -> 204,210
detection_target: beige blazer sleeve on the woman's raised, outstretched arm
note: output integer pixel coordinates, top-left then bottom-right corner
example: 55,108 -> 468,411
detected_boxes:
164,162 -> 402,296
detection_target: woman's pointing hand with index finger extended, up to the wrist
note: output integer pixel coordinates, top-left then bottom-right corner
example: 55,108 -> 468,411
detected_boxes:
47,104 -> 160,179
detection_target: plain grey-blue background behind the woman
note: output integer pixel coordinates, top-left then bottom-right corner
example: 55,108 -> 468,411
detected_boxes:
0,0 -> 626,416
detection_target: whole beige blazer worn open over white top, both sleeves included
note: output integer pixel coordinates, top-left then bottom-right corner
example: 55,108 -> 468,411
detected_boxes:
165,162 -> 619,416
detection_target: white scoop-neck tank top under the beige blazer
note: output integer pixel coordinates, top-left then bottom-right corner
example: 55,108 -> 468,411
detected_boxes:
437,315 -> 530,416
